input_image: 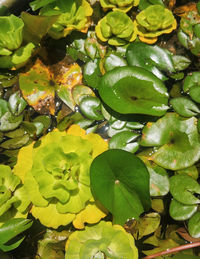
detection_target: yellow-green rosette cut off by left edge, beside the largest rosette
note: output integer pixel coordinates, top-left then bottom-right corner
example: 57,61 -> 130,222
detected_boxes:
0,165 -> 30,226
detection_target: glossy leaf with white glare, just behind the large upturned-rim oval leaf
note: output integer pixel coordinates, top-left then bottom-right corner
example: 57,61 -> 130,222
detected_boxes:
126,42 -> 175,80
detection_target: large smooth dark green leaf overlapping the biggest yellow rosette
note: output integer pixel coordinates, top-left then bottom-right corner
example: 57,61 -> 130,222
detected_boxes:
90,149 -> 151,225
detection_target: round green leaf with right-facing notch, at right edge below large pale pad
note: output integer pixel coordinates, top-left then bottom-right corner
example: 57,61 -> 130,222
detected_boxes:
170,175 -> 200,205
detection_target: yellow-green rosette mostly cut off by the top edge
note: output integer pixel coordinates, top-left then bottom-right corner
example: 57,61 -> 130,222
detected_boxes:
100,0 -> 140,13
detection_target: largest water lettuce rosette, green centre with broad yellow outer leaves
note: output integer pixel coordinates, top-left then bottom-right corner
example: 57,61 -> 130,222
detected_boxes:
14,125 -> 107,228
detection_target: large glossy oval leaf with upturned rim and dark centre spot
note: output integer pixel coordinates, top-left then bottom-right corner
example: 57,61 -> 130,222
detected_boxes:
98,66 -> 168,116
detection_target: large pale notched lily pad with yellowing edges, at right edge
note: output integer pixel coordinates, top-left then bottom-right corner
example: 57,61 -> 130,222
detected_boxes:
140,113 -> 200,170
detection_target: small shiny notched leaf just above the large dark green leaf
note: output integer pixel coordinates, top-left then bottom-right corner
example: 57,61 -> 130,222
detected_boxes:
109,131 -> 139,153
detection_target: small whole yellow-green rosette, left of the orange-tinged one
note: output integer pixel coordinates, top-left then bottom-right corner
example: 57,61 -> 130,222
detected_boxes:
95,11 -> 136,46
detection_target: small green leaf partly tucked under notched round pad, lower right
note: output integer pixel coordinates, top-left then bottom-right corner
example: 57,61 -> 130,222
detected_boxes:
169,199 -> 198,220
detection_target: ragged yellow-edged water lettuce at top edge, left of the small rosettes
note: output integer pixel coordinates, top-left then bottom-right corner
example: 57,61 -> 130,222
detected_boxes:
30,0 -> 93,39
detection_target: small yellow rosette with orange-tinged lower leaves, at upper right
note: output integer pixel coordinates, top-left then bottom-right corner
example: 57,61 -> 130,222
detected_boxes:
134,5 -> 177,44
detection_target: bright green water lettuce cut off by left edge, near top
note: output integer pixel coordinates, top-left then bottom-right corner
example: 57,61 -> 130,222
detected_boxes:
0,14 -> 35,69
